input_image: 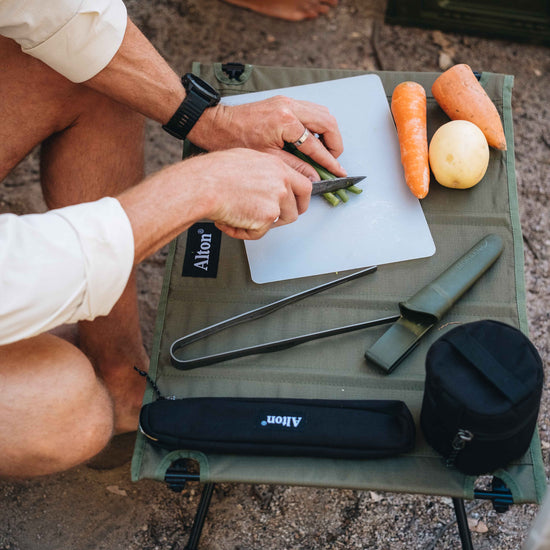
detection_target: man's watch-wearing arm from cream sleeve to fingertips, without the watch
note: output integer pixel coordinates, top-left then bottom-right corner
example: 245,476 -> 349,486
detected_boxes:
0,0 -> 345,175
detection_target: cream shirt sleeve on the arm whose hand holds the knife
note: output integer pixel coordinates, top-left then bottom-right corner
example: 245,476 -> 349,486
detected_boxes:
0,197 -> 134,345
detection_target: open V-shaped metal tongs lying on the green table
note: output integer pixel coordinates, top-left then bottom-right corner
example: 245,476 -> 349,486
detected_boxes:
170,266 -> 400,370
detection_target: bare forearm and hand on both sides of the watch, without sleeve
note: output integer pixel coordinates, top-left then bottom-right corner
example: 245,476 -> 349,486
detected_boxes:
84,20 -> 346,181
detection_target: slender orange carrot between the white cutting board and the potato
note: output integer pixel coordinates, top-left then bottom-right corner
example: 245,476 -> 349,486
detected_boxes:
391,81 -> 430,199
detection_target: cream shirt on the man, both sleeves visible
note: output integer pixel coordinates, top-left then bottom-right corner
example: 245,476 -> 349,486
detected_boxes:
0,0 -> 134,345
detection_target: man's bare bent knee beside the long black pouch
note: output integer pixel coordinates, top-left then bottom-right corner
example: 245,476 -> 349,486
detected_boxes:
0,334 -> 113,477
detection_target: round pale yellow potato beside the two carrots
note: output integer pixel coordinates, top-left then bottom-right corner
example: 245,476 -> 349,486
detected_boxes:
428,120 -> 489,189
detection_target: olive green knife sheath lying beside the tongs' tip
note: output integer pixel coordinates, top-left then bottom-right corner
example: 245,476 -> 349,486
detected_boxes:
365,234 -> 503,374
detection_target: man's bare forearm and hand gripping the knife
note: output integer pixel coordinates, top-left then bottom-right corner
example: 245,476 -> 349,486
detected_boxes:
118,149 -> 311,263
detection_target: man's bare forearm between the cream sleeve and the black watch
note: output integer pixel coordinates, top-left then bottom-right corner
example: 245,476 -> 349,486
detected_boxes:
84,19 -> 185,124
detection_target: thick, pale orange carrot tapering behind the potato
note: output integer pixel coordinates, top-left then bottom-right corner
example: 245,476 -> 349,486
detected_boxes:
432,63 -> 506,151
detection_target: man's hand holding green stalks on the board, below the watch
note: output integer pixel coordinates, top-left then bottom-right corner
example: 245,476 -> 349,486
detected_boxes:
189,96 -> 346,181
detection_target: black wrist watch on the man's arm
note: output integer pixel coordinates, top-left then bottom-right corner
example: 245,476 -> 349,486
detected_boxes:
162,73 -> 221,139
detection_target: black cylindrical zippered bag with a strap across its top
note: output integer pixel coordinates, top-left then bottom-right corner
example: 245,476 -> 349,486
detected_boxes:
420,320 -> 543,475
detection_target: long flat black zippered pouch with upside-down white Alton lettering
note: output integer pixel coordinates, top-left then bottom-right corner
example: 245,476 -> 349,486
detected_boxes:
140,397 -> 415,458
